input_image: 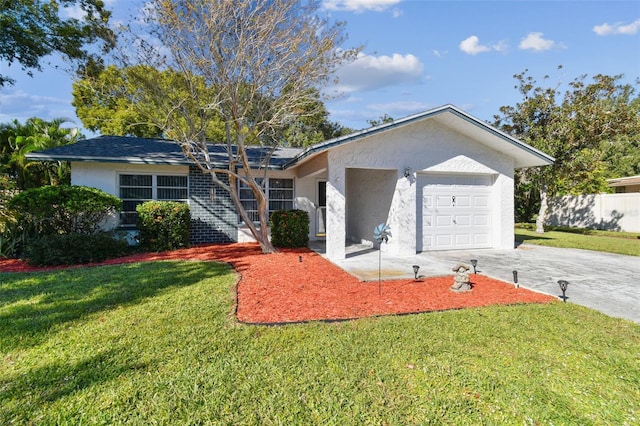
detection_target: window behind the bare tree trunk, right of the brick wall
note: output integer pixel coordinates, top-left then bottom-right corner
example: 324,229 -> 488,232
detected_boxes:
238,178 -> 294,222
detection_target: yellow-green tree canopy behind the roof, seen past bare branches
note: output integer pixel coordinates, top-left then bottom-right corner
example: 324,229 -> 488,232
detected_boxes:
73,65 -> 344,146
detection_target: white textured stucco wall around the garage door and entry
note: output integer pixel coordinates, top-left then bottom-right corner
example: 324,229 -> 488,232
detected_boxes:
327,121 -> 514,259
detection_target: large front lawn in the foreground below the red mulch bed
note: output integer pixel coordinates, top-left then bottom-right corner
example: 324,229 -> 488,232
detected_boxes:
0,261 -> 640,425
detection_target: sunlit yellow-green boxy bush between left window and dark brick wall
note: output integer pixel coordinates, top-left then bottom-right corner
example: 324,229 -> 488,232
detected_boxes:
136,201 -> 191,251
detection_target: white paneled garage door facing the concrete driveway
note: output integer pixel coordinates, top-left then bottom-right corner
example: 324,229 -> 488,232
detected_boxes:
420,175 -> 492,251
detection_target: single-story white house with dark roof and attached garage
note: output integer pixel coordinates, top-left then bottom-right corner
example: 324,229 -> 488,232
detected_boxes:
28,105 -> 553,260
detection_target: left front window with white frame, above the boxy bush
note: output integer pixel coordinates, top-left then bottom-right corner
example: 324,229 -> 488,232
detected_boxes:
119,174 -> 188,228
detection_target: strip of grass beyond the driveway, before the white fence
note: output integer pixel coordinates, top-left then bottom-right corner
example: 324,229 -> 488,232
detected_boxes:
515,223 -> 640,256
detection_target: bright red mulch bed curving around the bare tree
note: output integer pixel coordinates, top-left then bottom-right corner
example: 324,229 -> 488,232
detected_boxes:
0,244 -> 557,324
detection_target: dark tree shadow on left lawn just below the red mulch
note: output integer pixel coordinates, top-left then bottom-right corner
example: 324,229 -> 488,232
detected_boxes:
0,262 -> 229,353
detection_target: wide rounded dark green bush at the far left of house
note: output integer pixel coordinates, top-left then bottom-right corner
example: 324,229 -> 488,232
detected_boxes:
7,185 -> 122,237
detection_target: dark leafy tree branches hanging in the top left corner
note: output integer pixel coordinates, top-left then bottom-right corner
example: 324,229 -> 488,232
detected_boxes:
0,0 -> 115,87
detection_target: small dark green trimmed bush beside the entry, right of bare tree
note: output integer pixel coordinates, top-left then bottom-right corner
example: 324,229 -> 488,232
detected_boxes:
271,210 -> 309,248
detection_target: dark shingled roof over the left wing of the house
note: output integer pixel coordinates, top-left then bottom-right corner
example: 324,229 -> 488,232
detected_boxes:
27,136 -> 302,168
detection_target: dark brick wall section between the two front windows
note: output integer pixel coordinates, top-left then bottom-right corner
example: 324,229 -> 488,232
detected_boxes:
189,166 -> 238,244
